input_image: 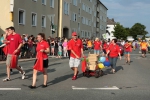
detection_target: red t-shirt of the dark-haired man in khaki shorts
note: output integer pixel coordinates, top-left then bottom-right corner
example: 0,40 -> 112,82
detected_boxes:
6,33 -> 22,55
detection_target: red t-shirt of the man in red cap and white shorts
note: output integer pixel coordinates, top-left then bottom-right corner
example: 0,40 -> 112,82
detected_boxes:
69,39 -> 83,58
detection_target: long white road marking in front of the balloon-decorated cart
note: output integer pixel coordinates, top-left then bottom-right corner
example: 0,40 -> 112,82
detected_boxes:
72,86 -> 120,90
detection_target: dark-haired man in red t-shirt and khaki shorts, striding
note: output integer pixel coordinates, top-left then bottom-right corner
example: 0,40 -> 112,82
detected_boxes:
3,27 -> 25,81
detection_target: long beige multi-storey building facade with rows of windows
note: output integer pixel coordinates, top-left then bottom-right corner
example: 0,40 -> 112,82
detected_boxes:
0,0 -> 108,38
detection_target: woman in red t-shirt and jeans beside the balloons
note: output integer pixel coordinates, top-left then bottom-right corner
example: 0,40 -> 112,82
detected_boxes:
106,39 -> 121,73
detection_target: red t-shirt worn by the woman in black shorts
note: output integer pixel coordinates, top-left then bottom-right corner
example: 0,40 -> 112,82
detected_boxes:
36,41 -> 49,59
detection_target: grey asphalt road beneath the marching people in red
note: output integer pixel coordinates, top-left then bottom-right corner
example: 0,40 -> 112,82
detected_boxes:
0,51 -> 150,100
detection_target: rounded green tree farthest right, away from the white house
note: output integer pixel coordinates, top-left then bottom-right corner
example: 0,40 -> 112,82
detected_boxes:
130,23 -> 148,39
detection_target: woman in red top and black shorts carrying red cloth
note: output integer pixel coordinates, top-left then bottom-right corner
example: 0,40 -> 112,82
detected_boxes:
29,33 -> 50,89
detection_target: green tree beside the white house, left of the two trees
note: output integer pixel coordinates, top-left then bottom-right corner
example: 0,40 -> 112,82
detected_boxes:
113,23 -> 127,39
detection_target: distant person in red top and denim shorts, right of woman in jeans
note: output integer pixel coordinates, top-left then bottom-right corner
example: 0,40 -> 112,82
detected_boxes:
124,40 -> 132,65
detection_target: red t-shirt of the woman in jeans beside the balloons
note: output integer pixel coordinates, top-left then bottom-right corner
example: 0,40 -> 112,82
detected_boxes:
108,44 -> 120,57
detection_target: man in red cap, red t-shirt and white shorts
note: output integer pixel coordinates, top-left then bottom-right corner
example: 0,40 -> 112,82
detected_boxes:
69,32 -> 83,80
